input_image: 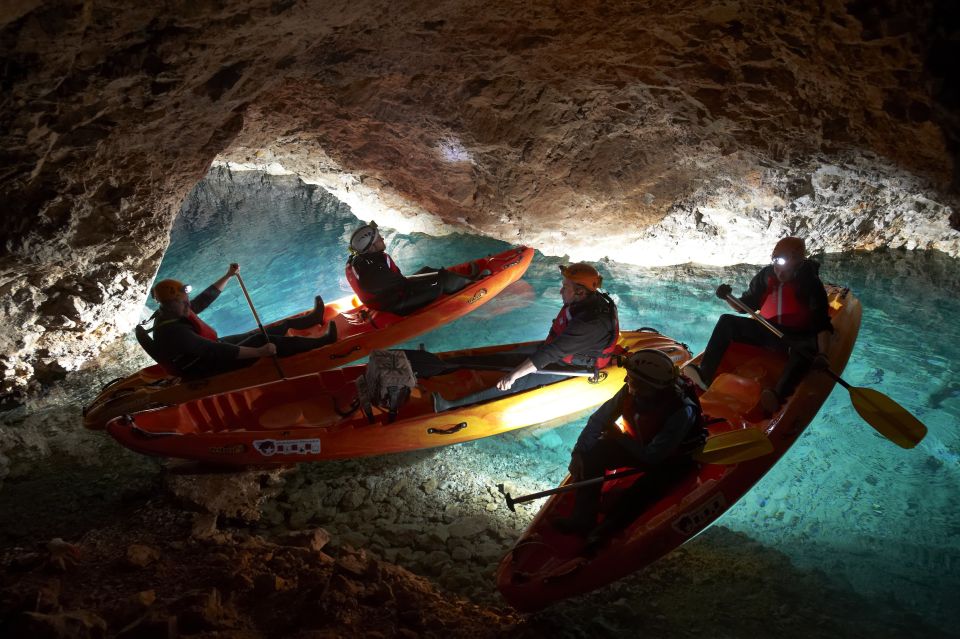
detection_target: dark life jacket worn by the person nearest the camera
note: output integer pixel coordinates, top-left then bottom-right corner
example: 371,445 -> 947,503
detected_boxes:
620,376 -> 707,452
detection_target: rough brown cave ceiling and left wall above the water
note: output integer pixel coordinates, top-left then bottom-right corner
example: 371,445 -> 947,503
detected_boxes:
0,0 -> 960,397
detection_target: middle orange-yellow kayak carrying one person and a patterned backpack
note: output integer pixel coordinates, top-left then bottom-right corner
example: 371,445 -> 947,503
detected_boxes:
107,330 -> 690,465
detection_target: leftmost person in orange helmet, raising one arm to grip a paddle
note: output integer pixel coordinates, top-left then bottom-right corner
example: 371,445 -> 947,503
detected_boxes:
144,264 -> 337,379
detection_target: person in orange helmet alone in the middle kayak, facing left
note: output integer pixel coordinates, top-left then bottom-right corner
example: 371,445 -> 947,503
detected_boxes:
424,262 -> 620,412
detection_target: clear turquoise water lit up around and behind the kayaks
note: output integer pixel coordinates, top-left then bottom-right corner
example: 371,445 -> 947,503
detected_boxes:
158,172 -> 960,627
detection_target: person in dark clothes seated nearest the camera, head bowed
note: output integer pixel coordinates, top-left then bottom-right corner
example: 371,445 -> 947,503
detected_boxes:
553,349 -> 706,547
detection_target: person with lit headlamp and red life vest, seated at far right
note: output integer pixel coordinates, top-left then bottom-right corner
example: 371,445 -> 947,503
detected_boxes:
684,237 -> 833,414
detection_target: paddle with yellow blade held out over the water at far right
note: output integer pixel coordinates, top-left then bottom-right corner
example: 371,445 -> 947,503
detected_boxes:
726,294 -> 927,448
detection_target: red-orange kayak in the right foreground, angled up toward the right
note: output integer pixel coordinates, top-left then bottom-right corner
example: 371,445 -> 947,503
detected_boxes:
497,286 -> 861,612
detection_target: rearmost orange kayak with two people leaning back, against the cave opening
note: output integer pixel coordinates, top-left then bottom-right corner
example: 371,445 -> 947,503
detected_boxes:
83,246 -> 534,430
